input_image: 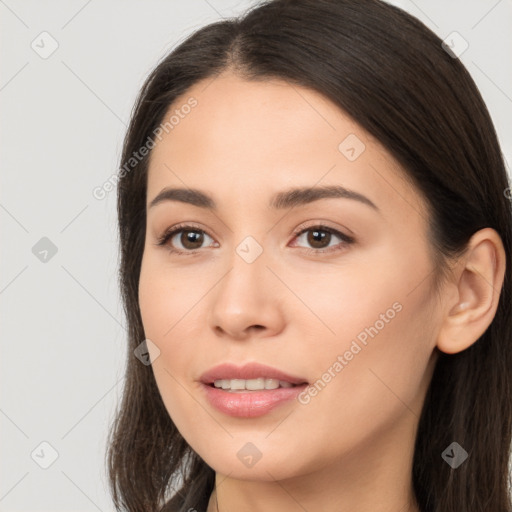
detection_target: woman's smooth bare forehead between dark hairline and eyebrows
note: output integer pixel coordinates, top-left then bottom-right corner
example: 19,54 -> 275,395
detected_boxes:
147,73 -> 425,222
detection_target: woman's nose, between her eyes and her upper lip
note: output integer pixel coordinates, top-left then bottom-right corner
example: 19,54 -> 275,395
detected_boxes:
210,243 -> 289,340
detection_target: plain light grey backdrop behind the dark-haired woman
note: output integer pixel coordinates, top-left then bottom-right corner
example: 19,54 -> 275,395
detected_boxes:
0,0 -> 512,512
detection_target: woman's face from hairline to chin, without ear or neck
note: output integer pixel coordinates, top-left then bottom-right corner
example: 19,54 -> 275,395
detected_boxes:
139,73 -> 439,480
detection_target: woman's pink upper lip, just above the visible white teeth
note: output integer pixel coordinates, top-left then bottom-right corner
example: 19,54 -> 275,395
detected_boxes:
200,363 -> 307,384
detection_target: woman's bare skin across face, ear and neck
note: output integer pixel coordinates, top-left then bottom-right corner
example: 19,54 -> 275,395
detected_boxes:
139,72 -> 505,512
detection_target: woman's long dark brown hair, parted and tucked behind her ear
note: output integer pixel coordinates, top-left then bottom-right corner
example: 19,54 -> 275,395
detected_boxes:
107,0 -> 512,512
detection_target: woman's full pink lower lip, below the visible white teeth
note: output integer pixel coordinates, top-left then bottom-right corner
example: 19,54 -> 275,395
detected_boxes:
201,384 -> 307,418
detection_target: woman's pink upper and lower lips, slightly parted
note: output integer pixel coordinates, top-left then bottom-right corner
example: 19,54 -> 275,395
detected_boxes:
200,363 -> 308,418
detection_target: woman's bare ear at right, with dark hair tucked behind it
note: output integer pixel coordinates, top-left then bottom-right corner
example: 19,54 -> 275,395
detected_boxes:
437,228 -> 506,354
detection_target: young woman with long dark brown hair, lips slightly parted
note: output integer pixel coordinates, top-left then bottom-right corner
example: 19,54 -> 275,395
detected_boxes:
108,0 -> 512,512
